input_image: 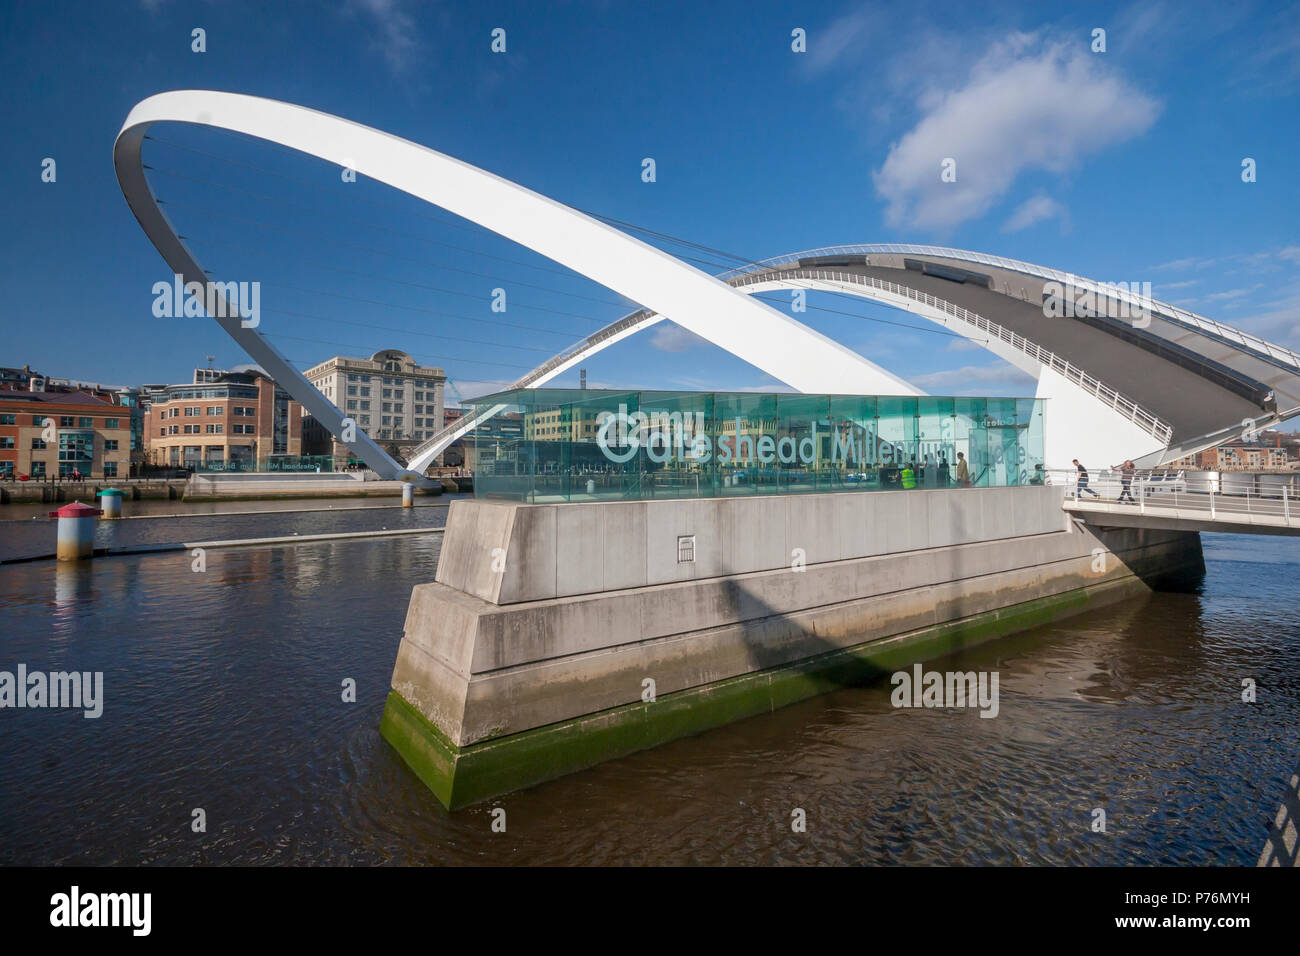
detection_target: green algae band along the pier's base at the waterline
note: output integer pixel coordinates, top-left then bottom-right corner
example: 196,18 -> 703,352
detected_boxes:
380,578 -> 1148,810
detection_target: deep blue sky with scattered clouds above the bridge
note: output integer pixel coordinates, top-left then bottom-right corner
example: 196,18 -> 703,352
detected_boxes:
0,0 -> 1300,395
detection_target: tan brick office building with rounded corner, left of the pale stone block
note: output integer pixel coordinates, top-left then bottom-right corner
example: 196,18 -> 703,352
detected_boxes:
144,369 -> 303,471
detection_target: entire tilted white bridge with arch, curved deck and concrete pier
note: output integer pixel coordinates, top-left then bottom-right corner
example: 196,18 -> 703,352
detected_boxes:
113,91 -> 1300,808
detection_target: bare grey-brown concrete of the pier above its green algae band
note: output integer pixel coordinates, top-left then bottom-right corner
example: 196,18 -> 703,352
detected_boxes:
393,488 -> 1200,747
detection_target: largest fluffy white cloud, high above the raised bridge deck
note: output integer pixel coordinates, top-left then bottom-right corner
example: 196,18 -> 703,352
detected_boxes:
872,34 -> 1160,230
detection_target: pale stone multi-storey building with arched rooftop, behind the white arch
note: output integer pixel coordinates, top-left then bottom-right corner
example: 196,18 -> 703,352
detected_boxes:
303,349 -> 447,460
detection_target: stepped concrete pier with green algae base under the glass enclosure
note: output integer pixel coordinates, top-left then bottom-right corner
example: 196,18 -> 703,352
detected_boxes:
381,486 -> 1204,808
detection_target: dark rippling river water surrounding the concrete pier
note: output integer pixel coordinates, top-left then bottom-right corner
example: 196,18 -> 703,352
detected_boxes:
0,509 -> 1300,865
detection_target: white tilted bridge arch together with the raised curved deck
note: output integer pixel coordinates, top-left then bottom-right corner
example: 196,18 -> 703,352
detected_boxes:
113,90 -> 1300,477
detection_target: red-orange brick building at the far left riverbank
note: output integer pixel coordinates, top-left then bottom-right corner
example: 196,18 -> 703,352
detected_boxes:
0,390 -> 131,480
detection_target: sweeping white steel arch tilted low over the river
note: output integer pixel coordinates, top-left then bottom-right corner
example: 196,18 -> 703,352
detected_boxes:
113,90 -> 919,477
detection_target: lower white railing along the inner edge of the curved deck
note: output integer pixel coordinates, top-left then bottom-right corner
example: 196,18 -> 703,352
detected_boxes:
731,269 -> 1174,445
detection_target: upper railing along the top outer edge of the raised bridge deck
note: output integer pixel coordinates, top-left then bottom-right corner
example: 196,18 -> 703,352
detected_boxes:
718,243 -> 1300,369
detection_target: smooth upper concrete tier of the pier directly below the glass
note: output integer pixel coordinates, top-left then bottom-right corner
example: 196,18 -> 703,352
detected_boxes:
436,486 -> 1066,605
